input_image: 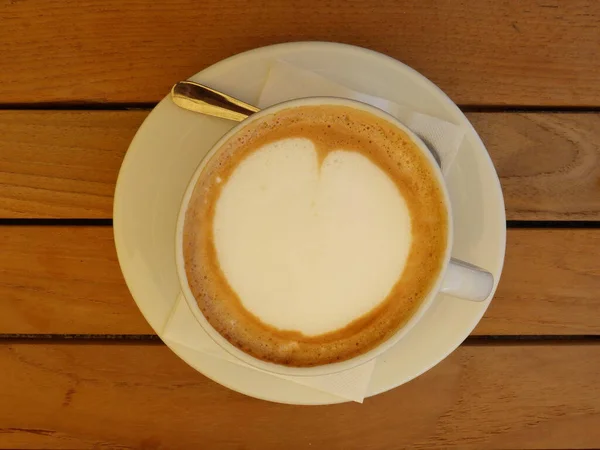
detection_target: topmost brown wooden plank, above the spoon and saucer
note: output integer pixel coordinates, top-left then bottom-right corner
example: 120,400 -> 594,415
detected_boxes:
0,0 -> 600,106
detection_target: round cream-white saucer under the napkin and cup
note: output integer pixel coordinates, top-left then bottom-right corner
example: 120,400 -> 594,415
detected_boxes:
114,42 -> 506,405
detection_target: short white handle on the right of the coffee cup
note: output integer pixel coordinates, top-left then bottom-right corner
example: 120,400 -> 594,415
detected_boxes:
440,258 -> 494,302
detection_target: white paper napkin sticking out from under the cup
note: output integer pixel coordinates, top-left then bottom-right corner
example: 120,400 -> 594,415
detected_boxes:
162,61 -> 464,403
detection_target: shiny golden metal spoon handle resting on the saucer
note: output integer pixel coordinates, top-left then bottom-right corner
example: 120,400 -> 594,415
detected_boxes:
171,81 -> 260,122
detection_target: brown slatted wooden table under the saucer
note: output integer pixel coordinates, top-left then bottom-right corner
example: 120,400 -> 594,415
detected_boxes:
0,0 -> 600,449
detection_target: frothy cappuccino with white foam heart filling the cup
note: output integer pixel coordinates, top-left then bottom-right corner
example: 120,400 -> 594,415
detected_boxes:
183,105 -> 448,367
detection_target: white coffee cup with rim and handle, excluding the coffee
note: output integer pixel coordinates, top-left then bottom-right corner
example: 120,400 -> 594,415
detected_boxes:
176,97 -> 494,376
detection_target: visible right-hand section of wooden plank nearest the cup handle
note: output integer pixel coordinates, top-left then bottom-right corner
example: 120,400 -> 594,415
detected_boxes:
474,229 -> 600,335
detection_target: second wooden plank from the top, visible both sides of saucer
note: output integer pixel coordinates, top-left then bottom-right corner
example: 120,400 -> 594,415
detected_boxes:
0,110 -> 600,220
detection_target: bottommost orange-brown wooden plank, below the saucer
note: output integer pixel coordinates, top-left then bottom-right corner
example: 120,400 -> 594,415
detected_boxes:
0,344 -> 600,450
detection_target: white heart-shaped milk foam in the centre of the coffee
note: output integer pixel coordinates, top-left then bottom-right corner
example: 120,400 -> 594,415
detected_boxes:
213,138 -> 412,335
